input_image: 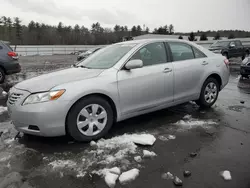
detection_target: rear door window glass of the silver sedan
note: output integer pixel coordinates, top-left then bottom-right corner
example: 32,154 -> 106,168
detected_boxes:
168,42 -> 195,61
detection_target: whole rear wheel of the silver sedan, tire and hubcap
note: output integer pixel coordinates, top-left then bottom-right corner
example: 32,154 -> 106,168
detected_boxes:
196,78 -> 219,108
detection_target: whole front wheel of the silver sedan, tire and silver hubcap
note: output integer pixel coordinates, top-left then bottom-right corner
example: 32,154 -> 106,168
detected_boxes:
67,96 -> 114,142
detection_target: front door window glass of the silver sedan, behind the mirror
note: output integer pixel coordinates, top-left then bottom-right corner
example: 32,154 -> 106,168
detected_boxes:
131,42 -> 167,66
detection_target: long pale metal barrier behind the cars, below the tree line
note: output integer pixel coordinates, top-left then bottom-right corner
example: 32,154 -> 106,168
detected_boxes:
12,38 -> 250,56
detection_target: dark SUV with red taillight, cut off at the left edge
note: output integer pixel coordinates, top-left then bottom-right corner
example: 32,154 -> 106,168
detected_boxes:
0,41 -> 21,83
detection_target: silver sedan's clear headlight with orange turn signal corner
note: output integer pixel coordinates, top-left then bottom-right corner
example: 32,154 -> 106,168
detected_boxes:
23,89 -> 65,105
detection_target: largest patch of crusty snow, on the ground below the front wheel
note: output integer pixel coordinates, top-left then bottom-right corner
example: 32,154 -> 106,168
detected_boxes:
44,134 -> 156,178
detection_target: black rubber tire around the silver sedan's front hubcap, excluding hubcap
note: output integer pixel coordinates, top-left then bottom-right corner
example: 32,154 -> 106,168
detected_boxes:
66,96 -> 114,142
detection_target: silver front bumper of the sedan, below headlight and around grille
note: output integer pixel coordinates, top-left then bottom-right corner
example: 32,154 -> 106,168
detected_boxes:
7,89 -> 68,137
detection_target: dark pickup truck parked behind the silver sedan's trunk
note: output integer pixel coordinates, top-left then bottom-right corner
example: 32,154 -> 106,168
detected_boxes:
209,40 -> 250,60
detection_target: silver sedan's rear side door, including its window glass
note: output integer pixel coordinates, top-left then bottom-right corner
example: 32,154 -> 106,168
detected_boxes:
167,42 -> 209,102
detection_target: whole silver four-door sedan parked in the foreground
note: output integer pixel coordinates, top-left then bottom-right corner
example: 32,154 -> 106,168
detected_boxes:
7,39 -> 229,141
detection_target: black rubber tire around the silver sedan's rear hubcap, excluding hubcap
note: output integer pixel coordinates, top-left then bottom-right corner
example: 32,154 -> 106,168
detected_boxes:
196,77 -> 220,108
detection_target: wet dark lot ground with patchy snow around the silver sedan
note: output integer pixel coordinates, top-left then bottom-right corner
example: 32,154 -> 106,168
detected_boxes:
0,55 -> 250,188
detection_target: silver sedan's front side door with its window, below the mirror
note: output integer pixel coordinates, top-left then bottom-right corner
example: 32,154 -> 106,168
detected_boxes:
117,42 -> 173,115
